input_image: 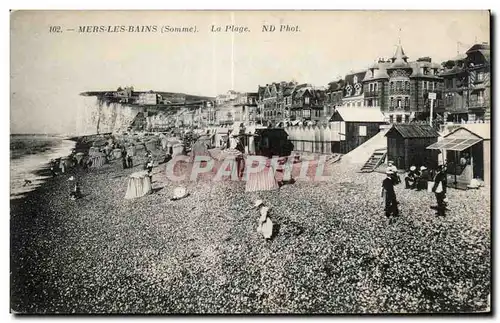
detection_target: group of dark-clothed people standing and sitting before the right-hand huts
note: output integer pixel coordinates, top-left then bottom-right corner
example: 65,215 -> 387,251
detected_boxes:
381,161 -> 447,222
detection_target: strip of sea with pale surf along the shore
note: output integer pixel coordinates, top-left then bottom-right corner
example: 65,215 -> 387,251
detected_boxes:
10,134 -> 75,199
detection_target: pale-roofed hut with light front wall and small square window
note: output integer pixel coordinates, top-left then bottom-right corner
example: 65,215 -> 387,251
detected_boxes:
330,107 -> 385,154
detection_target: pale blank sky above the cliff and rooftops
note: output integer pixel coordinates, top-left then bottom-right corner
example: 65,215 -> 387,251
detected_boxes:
10,11 -> 490,133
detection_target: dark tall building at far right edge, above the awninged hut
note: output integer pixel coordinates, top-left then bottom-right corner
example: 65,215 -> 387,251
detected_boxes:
440,43 -> 491,123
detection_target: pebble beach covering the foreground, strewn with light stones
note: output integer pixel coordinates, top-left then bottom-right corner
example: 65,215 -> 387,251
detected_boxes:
10,146 -> 491,314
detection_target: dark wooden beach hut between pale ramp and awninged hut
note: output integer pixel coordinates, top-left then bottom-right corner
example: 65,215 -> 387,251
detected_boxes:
385,124 -> 439,170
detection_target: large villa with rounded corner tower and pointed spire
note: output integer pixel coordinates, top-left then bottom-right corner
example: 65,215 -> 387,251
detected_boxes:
362,43 -> 444,123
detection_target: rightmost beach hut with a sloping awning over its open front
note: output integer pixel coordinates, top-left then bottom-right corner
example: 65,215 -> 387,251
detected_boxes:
427,123 -> 491,187
